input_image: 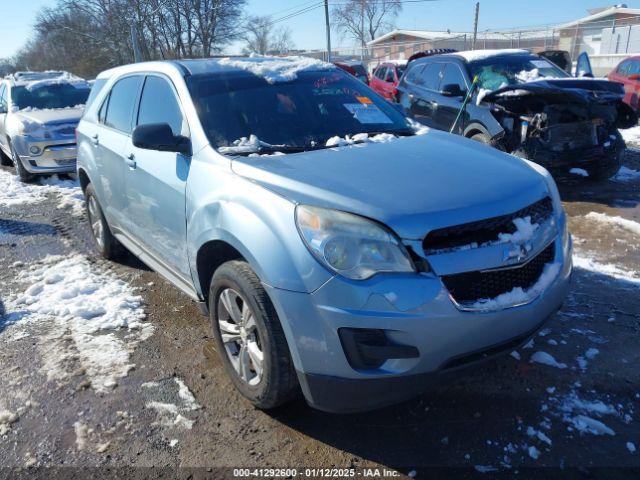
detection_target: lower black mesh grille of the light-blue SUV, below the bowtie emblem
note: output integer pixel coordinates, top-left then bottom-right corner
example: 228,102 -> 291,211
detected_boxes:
442,243 -> 555,305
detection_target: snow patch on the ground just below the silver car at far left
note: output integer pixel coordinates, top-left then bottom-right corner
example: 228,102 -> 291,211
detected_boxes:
0,170 -> 84,215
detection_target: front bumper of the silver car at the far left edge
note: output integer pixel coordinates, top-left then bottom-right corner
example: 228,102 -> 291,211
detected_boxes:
12,135 -> 77,174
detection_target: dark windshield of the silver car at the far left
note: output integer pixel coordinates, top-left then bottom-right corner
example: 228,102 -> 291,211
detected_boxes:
11,83 -> 90,110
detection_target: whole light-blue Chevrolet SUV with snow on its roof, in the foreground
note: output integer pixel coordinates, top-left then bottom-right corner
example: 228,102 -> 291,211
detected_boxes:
78,57 -> 571,412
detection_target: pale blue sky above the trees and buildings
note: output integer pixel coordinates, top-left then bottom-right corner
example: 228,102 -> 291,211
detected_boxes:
0,0 -> 640,58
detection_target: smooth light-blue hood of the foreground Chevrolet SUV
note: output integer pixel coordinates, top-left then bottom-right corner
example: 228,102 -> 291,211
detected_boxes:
232,131 -> 548,240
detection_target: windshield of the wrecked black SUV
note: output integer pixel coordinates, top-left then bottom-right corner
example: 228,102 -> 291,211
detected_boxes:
468,55 -> 569,90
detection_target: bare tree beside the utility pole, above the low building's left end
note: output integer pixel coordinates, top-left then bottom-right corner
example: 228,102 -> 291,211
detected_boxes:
331,0 -> 402,46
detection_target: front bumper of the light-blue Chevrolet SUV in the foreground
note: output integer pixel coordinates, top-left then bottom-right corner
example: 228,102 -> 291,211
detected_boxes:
266,229 -> 572,412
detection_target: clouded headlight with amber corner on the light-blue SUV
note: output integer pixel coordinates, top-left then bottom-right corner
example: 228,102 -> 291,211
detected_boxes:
296,205 -> 415,280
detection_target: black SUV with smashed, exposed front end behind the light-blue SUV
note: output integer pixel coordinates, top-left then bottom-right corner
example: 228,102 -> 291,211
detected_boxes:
398,50 -> 637,179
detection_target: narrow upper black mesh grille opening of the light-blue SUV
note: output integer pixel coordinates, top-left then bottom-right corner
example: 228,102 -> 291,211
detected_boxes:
422,197 -> 553,255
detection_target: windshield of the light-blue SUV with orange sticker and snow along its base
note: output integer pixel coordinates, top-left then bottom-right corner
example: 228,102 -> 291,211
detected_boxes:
188,69 -> 413,149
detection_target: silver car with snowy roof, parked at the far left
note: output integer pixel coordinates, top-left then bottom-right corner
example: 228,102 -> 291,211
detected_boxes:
0,71 -> 91,182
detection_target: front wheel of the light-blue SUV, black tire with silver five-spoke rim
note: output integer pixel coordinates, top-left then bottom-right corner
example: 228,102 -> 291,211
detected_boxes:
209,260 -> 298,410
